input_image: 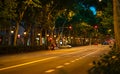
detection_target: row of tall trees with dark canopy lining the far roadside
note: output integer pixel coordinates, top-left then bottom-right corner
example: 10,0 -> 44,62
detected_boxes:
0,0 -> 113,46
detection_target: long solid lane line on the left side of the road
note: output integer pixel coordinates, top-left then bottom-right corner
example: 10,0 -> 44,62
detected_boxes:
0,57 -> 56,71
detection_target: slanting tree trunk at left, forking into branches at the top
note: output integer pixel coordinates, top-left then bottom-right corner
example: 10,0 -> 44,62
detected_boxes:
14,0 -> 41,46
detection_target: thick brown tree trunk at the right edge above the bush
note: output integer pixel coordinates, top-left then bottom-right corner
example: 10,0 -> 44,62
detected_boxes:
113,0 -> 120,48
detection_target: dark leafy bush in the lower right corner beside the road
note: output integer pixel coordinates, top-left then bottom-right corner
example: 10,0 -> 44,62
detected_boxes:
89,48 -> 120,74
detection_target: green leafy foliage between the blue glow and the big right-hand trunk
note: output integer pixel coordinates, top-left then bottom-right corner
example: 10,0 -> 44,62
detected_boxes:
97,1 -> 114,35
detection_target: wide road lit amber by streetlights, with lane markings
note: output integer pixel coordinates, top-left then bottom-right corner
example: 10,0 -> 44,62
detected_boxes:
0,45 -> 110,74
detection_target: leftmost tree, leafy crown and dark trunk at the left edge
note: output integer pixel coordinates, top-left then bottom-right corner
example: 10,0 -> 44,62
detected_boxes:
0,0 -> 17,44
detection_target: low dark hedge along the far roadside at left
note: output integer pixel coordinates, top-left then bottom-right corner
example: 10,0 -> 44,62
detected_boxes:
0,46 -> 47,55
